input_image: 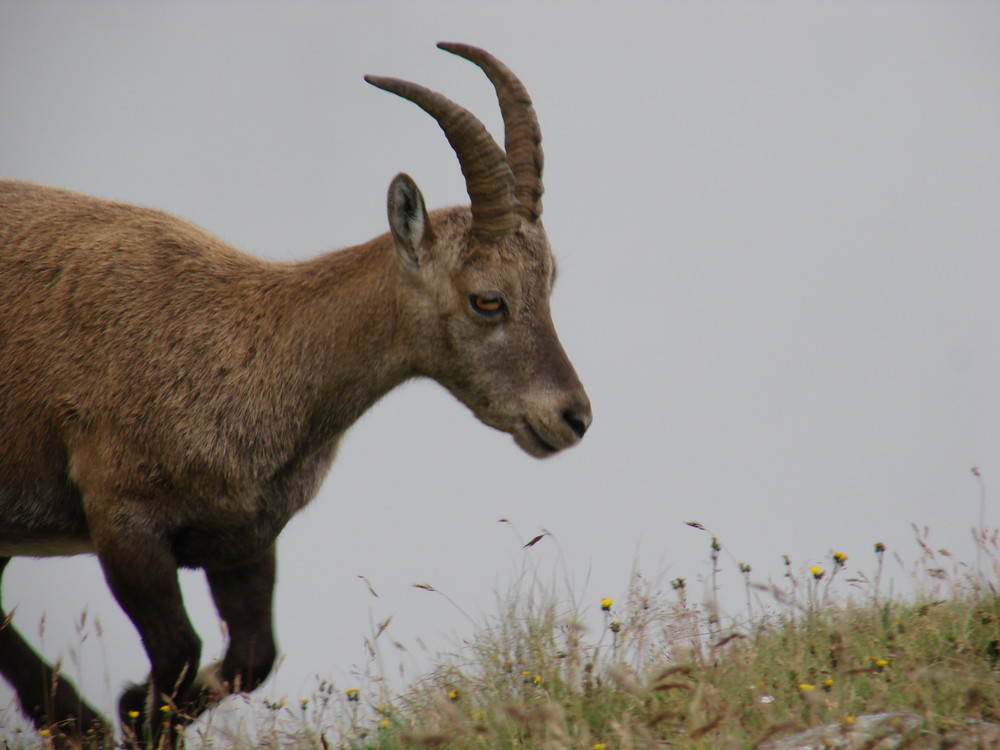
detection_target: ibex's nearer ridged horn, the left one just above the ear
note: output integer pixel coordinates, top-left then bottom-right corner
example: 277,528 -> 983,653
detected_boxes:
365,76 -> 519,236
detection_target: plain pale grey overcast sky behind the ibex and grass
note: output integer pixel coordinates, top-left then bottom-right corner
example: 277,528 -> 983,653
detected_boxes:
0,0 -> 1000,740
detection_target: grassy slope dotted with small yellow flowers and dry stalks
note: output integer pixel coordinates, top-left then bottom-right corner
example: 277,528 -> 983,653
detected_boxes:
21,524 -> 1000,750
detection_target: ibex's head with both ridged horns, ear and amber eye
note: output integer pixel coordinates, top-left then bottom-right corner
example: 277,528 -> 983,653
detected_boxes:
366,43 -> 591,457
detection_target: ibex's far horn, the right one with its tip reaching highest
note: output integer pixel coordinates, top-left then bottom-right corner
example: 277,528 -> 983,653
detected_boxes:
438,42 -> 545,221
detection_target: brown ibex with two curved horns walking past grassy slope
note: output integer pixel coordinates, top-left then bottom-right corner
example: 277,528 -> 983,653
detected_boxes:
0,43 -> 591,736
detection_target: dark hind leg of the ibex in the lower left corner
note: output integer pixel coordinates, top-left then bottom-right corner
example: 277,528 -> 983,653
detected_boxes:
0,557 -> 112,747
